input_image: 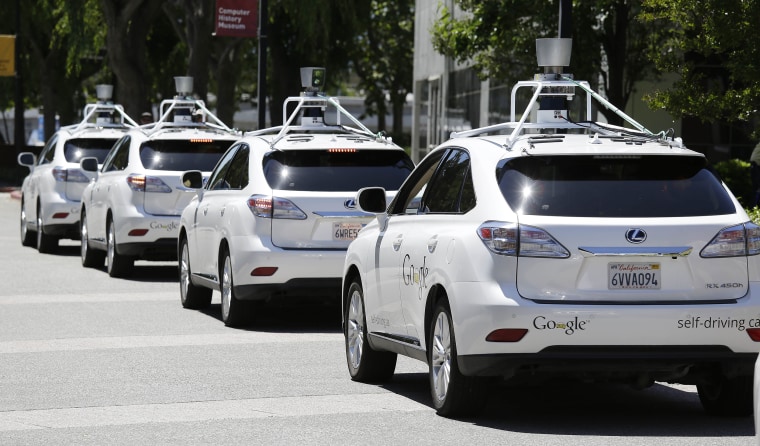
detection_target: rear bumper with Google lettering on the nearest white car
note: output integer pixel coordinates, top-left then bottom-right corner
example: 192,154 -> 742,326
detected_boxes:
449,282 -> 760,382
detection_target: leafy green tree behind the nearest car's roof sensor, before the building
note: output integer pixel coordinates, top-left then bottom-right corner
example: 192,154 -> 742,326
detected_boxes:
433,0 -> 656,124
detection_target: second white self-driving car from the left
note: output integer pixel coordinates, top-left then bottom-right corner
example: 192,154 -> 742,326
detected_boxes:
79,77 -> 240,277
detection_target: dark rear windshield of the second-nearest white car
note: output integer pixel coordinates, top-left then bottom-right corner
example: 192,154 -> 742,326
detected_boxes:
264,150 -> 414,192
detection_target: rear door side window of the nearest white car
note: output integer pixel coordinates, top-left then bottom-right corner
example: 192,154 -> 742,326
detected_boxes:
421,149 -> 475,213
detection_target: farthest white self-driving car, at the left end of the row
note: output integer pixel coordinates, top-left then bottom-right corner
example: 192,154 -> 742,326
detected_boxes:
18,85 -> 138,253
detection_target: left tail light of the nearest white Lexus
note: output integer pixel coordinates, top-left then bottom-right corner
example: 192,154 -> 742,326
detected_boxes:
478,221 -> 570,258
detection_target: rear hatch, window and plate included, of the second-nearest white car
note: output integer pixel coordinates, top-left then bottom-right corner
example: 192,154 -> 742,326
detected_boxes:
263,148 -> 414,249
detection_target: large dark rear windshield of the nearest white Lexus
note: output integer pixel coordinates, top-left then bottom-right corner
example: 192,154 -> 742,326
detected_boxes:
496,155 -> 736,217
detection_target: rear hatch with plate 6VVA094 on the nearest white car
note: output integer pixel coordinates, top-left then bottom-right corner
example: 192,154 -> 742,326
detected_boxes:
499,155 -> 757,303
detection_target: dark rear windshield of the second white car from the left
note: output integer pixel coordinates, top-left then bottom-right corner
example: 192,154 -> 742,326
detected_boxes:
140,138 -> 234,172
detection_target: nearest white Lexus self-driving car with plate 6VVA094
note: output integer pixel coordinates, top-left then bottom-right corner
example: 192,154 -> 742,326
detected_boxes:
343,39 -> 760,416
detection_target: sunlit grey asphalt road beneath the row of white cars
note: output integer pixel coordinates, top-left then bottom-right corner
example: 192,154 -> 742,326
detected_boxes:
0,193 -> 755,446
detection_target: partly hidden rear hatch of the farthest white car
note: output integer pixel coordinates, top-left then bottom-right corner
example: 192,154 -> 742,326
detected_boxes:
63,134 -> 119,201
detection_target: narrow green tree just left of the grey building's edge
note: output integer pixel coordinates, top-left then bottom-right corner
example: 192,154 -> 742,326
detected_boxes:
350,0 -> 414,142
